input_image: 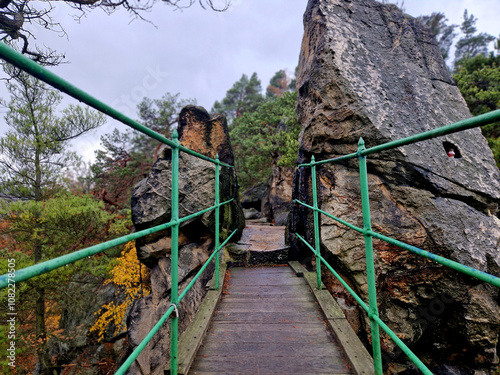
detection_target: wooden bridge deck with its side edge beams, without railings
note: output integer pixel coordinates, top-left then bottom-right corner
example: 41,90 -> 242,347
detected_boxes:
184,263 -> 373,375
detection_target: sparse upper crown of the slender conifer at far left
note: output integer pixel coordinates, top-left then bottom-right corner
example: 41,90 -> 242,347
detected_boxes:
0,67 -> 104,200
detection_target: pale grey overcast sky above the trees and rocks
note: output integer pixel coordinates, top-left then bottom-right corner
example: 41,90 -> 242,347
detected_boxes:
0,0 -> 500,164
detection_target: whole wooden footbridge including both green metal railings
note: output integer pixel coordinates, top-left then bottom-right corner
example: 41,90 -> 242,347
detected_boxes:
0,43 -> 500,375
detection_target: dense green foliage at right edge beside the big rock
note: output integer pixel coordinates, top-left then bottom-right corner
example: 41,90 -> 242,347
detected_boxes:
453,53 -> 500,167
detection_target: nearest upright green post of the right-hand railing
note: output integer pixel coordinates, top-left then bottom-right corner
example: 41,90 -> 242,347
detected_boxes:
358,138 -> 382,375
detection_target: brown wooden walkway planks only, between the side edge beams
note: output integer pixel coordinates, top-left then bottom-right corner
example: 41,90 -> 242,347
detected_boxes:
189,266 -> 352,375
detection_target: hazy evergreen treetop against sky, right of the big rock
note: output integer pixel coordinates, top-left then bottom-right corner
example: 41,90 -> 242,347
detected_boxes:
455,9 -> 495,70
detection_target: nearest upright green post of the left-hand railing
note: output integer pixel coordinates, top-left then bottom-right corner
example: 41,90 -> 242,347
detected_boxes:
170,130 -> 180,375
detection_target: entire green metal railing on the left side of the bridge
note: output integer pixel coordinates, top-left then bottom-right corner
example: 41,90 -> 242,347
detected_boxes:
0,43 -> 237,375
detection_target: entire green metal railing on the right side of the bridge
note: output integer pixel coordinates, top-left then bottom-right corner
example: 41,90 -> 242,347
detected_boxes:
294,110 -> 500,375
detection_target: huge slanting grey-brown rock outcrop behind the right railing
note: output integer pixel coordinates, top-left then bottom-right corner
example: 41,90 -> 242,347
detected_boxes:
289,0 -> 500,370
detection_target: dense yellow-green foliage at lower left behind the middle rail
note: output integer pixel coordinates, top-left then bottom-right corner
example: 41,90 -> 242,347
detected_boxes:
0,193 -> 130,372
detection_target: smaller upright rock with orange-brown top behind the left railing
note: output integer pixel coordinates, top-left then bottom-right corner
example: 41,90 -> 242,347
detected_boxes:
127,106 -> 244,374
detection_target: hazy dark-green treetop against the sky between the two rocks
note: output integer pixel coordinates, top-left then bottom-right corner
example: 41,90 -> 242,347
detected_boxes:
211,73 -> 264,122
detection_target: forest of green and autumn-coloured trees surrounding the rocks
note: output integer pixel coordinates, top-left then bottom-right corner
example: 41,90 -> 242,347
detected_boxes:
0,1 -> 500,374
